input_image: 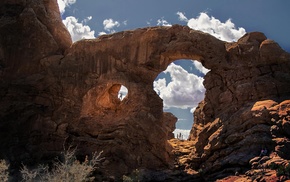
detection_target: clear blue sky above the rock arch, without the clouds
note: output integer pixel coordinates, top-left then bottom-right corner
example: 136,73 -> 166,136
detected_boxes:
59,0 -> 290,52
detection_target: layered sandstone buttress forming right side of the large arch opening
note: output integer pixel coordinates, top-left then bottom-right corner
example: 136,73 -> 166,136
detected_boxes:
190,32 -> 290,177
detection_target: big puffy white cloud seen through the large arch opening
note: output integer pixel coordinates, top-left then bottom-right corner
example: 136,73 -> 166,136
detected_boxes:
153,63 -> 205,109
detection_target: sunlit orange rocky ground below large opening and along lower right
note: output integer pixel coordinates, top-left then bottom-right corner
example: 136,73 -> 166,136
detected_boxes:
169,138 -> 290,182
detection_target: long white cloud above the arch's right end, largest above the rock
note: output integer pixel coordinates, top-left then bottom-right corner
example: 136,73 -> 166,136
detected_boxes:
177,12 -> 246,42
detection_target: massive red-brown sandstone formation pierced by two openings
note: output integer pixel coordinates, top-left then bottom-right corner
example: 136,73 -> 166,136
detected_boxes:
0,0 -> 290,179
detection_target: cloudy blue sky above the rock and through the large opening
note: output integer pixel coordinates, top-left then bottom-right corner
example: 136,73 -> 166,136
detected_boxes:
58,0 -> 290,139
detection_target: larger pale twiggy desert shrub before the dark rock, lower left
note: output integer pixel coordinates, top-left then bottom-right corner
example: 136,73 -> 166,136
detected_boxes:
20,147 -> 103,182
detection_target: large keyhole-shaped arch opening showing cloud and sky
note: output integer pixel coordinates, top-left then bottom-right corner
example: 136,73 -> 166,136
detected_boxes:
153,59 -> 209,140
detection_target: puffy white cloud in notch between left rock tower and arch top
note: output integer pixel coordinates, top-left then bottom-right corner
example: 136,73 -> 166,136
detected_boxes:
62,16 -> 95,42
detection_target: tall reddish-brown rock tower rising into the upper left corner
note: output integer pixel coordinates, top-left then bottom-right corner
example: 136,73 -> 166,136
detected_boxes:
0,0 -> 72,79
